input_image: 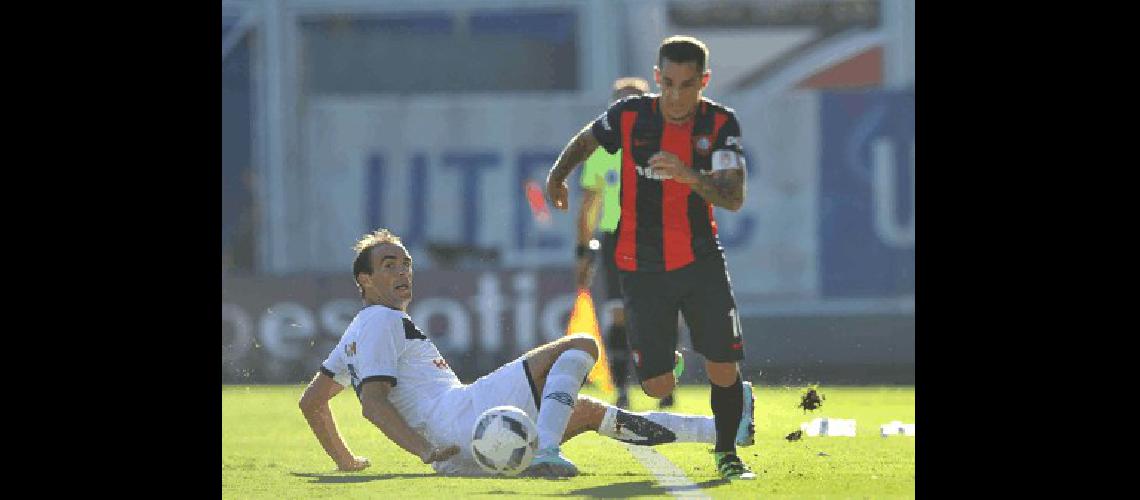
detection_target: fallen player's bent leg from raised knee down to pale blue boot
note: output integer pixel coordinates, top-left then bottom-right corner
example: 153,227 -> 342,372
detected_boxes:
522,335 -> 599,477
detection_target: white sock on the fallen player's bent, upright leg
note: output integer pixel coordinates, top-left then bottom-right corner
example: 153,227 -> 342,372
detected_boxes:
535,349 -> 595,450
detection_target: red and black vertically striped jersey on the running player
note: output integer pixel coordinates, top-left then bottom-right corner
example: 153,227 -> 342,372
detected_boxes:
592,93 -> 744,271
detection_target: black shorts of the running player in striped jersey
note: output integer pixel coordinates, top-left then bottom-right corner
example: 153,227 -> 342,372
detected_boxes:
619,255 -> 744,382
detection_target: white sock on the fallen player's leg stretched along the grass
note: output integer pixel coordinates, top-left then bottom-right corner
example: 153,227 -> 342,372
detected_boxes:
597,407 -> 716,445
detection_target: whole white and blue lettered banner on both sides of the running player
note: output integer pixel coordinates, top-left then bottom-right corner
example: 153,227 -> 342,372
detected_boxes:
289,91 -> 914,311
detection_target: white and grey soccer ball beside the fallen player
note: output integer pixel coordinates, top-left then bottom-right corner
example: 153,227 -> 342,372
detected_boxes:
471,407 -> 538,476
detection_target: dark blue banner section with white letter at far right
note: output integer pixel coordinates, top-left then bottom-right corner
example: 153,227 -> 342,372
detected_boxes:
819,91 -> 914,298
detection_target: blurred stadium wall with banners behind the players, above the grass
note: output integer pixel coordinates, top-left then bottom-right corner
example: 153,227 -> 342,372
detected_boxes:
222,0 -> 914,384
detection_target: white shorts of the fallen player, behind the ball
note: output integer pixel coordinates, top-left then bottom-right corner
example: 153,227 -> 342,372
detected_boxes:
426,358 -> 542,476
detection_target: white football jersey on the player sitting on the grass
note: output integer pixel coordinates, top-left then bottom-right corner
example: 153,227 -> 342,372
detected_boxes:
320,305 -> 463,433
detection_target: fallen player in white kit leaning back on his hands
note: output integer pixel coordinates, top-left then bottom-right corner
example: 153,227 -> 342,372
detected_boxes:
300,229 -> 755,477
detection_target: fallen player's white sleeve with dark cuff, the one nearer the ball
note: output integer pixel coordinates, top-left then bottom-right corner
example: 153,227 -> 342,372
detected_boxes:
348,314 -> 407,387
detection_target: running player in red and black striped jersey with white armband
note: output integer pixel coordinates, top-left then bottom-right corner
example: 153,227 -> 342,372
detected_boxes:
546,36 -> 756,479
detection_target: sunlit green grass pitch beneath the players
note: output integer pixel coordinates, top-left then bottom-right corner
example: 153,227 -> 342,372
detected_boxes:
221,385 -> 914,499
